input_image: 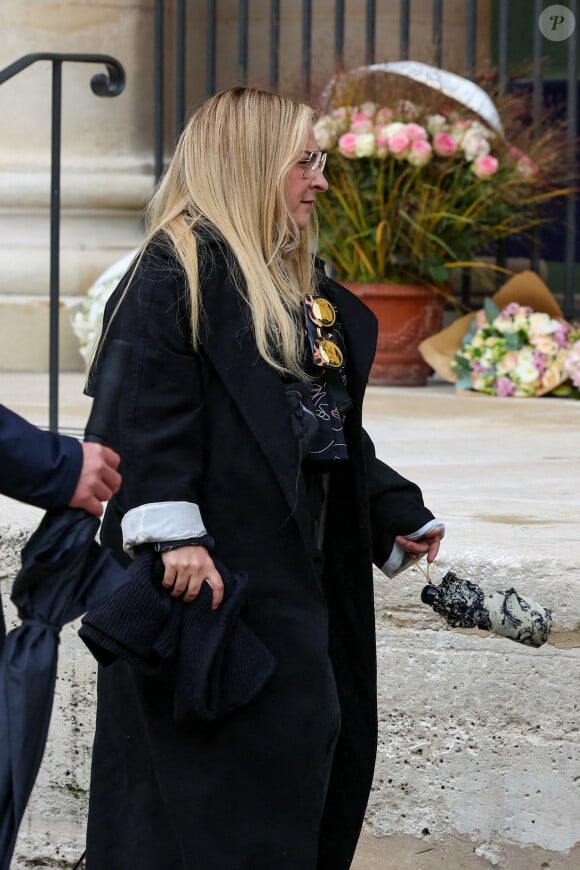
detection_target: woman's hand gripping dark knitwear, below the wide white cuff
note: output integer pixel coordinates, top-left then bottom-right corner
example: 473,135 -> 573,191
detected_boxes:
161,546 -> 224,610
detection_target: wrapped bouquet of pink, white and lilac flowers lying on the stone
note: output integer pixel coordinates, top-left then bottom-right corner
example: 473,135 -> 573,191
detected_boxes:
451,299 -> 580,398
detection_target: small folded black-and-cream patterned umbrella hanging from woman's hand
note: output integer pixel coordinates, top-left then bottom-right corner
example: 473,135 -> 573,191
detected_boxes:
421,571 -> 552,646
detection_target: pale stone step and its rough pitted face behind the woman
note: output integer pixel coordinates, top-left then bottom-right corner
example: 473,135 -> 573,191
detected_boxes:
0,373 -> 580,870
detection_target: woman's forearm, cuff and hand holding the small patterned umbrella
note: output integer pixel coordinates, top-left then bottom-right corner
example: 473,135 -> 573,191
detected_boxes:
363,432 -> 445,577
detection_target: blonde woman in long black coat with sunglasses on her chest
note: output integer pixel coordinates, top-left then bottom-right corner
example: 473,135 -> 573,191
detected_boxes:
87,87 -> 443,870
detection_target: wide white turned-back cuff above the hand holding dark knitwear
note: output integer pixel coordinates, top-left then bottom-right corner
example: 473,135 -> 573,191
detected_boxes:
121,501 -> 207,556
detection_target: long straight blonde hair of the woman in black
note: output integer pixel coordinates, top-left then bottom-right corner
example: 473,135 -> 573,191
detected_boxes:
124,87 -> 317,376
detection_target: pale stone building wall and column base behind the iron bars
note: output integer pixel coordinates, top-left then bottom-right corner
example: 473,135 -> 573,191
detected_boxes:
0,0 -> 491,371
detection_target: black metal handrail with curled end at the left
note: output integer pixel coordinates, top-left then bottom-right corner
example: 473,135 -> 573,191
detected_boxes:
0,52 -> 125,432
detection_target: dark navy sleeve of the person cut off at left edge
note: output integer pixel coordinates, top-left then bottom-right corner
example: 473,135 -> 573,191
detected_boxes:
0,405 -> 83,510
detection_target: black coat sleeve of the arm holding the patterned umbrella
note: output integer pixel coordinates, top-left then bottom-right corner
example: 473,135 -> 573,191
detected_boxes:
363,431 -> 434,566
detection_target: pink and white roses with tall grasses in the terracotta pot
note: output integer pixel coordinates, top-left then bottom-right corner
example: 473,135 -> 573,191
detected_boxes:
314,73 -> 568,288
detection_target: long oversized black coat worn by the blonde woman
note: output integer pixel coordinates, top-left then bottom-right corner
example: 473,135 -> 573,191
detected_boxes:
87,239 -> 432,870
